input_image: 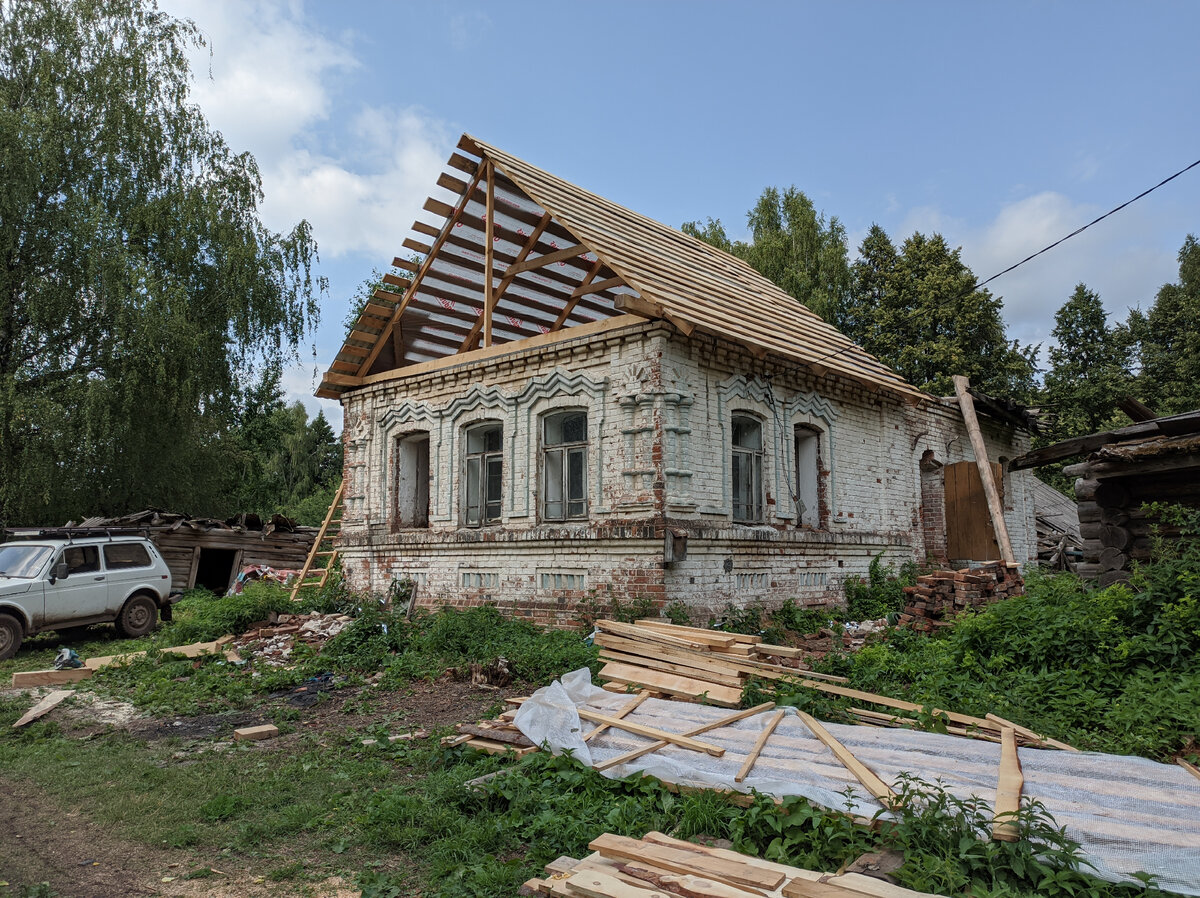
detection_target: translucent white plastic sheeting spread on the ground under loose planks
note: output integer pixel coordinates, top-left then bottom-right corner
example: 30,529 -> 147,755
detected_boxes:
515,669 -> 1200,896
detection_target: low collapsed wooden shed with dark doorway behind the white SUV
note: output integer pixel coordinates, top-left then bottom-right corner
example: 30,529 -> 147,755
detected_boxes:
78,509 -> 317,595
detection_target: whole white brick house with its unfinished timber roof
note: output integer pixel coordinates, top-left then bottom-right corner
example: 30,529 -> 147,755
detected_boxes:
318,137 -> 1036,623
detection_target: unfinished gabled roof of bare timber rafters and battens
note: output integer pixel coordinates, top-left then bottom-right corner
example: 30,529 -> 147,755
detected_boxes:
317,134 -> 931,405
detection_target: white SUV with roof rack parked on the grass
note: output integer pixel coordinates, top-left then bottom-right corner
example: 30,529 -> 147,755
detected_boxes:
0,531 -> 179,660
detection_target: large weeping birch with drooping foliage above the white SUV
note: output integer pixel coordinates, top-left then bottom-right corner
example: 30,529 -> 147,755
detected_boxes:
0,0 -> 323,523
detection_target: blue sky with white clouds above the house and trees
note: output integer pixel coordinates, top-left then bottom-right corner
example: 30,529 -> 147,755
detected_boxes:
163,0 -> 1200,426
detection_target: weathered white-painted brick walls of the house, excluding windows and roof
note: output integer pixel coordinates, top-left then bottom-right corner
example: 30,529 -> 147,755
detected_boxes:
333,323 -> 1034,624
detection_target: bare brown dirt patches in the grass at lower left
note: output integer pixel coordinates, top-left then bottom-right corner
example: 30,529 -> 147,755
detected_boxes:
0,678 -> 522,898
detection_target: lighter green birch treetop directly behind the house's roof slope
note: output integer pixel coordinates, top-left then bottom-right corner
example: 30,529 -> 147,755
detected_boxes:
683,186 -> 851,327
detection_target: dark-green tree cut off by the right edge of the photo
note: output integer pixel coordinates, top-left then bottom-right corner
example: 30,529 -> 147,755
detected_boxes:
1128,234 -> 1200,414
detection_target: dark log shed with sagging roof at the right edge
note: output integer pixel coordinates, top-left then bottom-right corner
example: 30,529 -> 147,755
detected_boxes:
1009,409 -> 1200,586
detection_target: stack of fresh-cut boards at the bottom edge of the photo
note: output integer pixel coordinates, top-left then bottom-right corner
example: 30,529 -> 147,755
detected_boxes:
521,832 -> 928,898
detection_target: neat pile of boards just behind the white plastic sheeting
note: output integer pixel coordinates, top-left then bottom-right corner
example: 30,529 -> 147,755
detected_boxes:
595,618 -> 845,708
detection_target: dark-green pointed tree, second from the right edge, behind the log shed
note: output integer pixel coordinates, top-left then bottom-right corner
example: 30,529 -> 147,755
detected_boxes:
1044,283 -> 1130,442
